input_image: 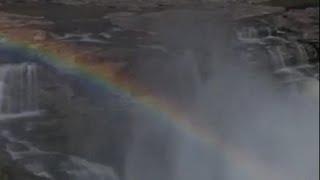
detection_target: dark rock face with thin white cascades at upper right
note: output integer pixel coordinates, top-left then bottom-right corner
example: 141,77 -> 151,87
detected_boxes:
237,5 -> 319,84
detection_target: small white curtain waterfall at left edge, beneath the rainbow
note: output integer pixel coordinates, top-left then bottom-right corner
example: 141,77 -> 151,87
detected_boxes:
0,63 -> 39,120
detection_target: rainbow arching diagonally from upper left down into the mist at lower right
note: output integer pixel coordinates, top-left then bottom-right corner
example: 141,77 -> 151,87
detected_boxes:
0,29 -> 288,180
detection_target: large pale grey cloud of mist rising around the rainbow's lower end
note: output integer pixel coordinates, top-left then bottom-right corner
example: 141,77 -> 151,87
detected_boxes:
125,9 -> 319,180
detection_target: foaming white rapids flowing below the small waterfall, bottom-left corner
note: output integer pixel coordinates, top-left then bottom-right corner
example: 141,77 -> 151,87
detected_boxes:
1,130 -> 119,180
